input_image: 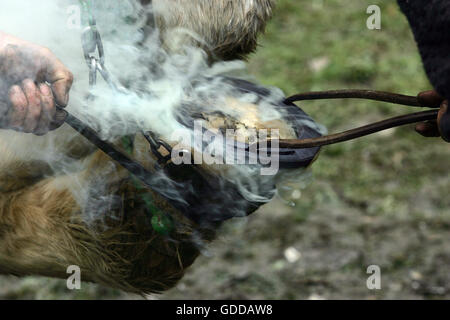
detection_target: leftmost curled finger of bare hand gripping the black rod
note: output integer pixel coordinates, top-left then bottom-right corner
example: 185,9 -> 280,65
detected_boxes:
6,86 -> 28,131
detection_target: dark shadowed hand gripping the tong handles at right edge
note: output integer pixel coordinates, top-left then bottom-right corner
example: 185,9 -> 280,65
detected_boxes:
416,90 -> 450,142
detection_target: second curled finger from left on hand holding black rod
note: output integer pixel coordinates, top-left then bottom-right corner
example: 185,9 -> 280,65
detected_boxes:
22,79 -> 42,133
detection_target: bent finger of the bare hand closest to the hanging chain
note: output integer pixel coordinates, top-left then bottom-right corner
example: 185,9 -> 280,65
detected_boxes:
45,50 -> 73,107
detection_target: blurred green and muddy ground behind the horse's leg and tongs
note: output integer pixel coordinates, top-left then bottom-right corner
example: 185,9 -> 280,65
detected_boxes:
0,0 -> 450,299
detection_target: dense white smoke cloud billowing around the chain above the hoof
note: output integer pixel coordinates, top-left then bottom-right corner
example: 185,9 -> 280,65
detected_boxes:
0,0 -> 288,139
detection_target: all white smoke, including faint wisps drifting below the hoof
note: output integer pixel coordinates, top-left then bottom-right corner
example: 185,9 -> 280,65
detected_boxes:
0,0 -> 324,226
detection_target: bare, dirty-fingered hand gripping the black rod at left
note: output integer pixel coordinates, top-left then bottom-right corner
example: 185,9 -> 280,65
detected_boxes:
0,32 -> 73,135
